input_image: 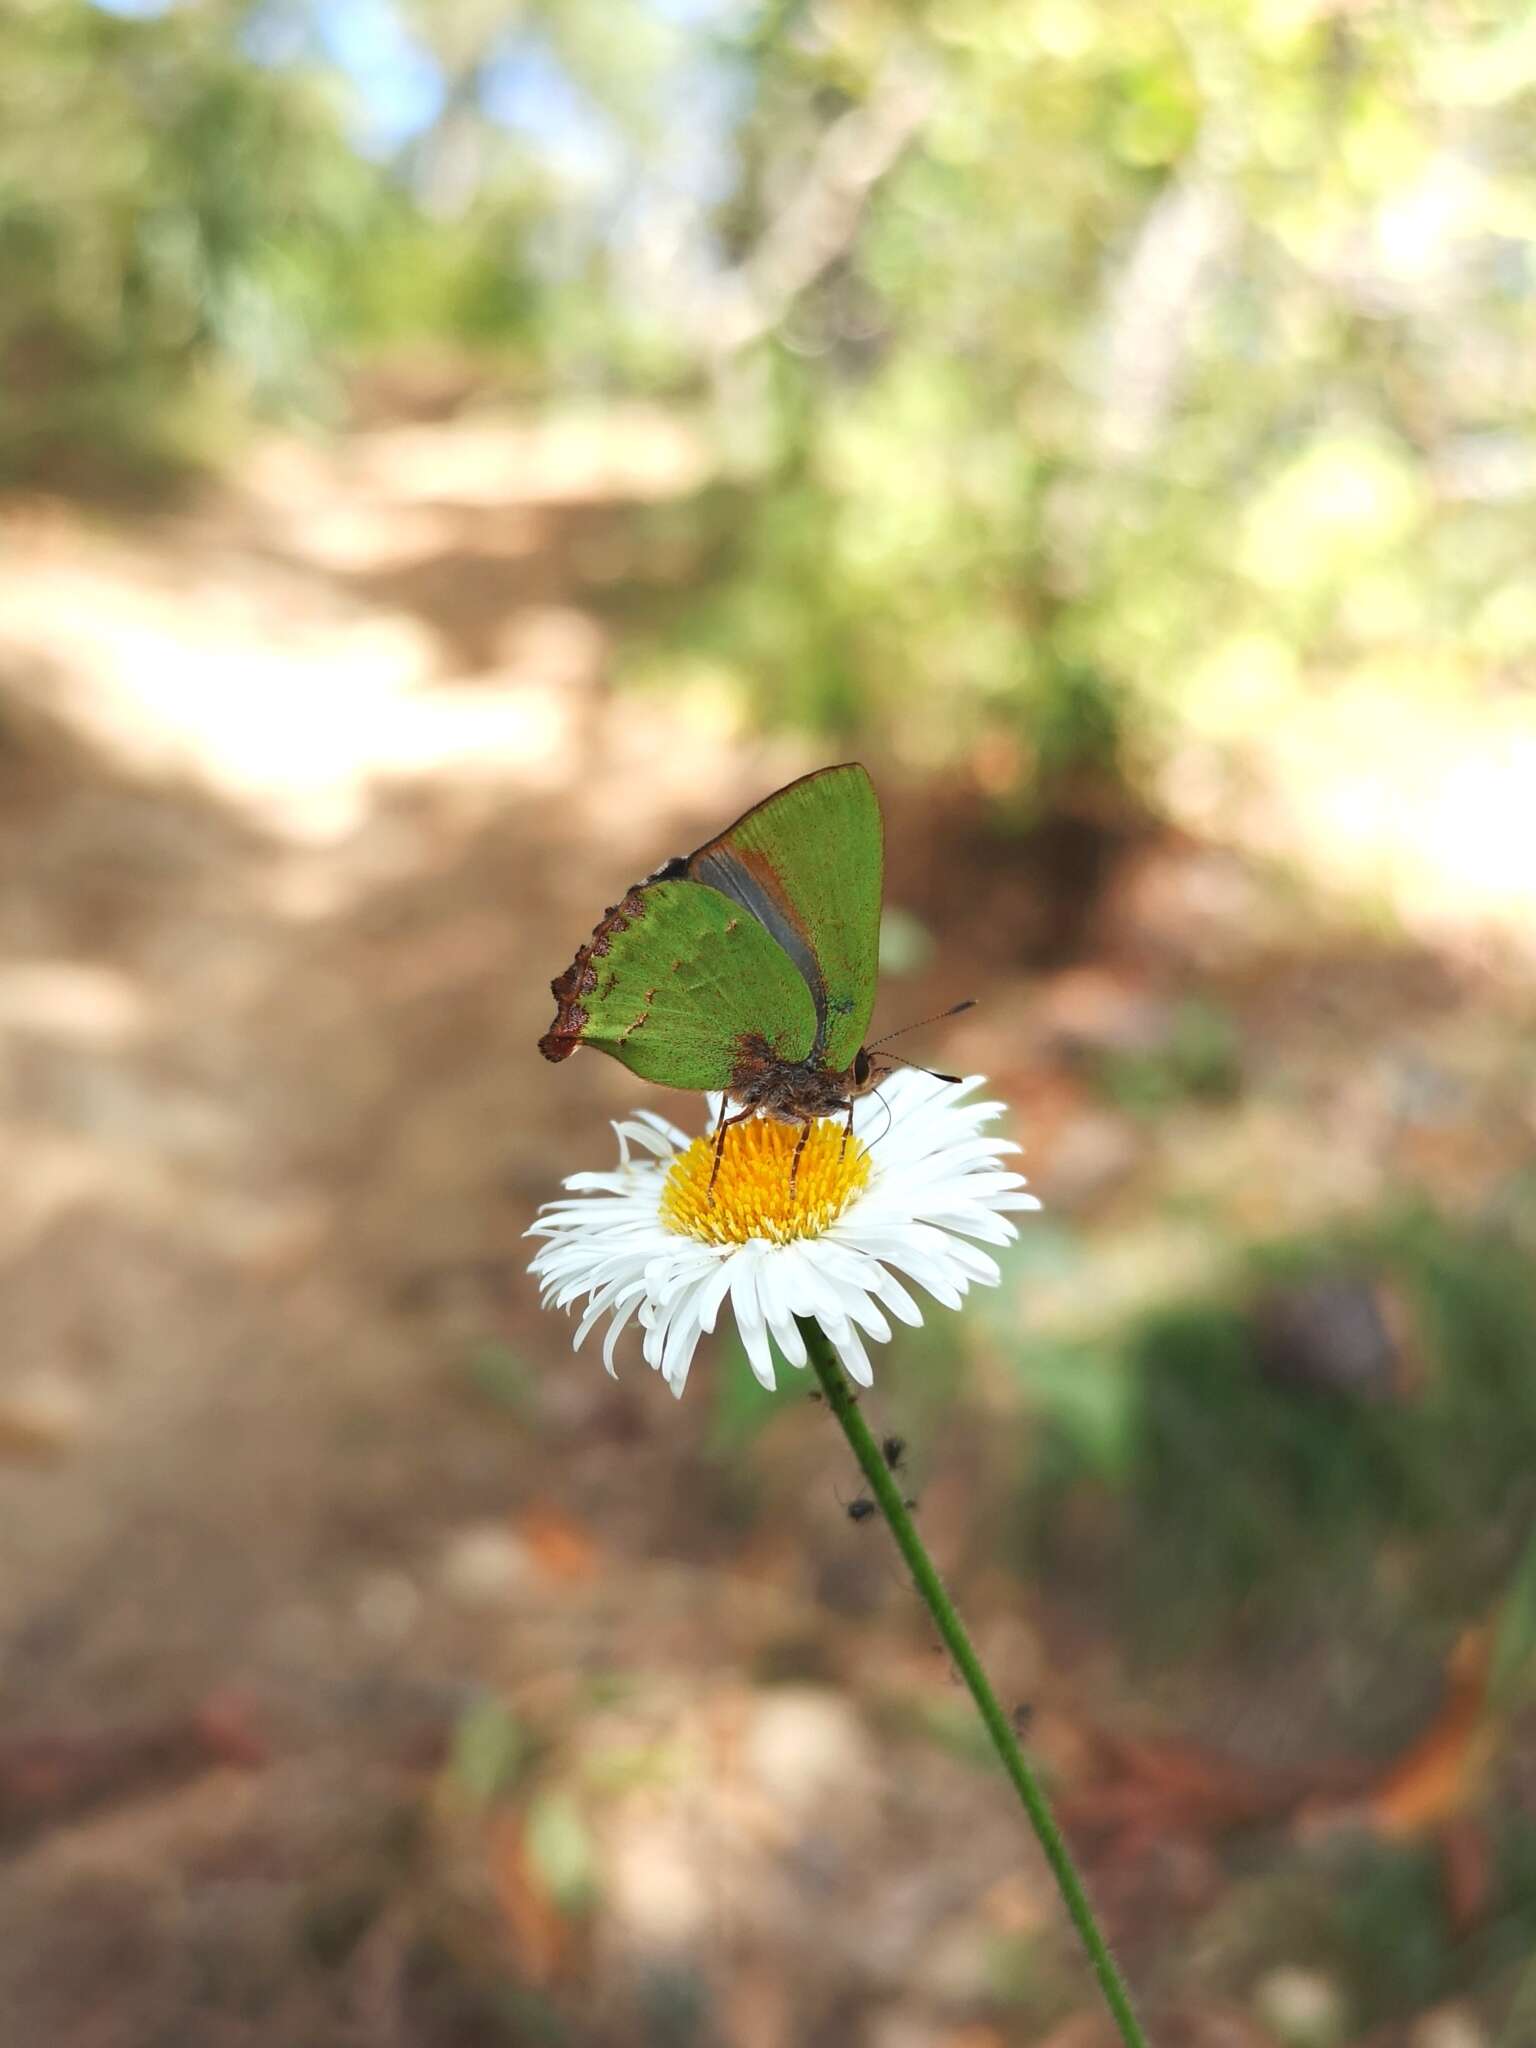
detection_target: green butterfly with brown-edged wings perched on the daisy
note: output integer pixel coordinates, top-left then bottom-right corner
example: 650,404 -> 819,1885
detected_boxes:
539,762 -> 950,1188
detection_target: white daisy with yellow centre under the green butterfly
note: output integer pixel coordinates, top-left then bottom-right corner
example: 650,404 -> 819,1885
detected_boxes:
528,1069 -> 1040,1395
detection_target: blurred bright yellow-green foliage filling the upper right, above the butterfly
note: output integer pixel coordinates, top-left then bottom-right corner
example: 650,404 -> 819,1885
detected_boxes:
647,0 -> 1536,803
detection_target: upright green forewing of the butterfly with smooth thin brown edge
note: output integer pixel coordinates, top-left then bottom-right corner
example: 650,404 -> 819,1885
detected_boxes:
666,762 -> 885,1073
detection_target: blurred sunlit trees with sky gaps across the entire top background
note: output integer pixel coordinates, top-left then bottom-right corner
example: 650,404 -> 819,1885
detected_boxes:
0,0 -> 1536,782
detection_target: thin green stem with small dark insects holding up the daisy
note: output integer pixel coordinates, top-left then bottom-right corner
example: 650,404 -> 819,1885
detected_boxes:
797,1317 -> 1147,2048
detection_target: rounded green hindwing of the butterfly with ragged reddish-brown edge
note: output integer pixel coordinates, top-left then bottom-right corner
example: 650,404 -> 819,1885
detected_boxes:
539,864 -> 817,1090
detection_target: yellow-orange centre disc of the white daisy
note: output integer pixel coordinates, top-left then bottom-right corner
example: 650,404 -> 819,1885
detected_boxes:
662,1116 -> 868,1245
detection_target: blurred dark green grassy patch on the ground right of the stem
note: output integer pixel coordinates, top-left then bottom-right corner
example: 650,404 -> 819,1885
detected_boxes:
1016,1212 -> 1536,1654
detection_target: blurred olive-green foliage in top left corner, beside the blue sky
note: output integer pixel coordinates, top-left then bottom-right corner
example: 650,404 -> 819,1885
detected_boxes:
0,0 -> 549,483
